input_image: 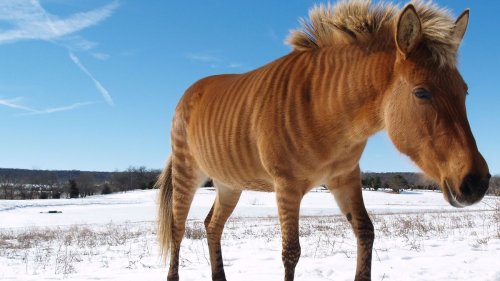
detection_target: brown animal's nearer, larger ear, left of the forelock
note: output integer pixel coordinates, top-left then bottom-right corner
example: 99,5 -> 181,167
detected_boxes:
396,4 -> 422,58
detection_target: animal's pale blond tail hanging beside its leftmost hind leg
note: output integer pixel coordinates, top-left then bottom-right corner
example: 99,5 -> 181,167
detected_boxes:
155,158 -> 173,263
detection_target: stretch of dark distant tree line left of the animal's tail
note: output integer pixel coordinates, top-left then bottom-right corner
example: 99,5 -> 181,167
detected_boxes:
0,167 -> 160,200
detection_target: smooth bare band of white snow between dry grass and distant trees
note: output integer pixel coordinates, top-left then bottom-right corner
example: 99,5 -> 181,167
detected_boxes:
0,186 -> 495,229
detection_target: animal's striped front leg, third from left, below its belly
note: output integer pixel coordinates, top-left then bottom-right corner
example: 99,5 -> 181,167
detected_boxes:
276,182 -> 303,281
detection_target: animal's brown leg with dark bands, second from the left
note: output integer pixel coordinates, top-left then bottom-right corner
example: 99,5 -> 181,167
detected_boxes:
205,181 -> 241,281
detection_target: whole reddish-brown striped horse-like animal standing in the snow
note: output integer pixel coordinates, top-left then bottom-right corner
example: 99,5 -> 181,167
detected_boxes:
157,0 -> 491,281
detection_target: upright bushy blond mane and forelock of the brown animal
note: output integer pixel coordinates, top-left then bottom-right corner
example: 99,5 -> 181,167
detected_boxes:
286,0 -> 460,66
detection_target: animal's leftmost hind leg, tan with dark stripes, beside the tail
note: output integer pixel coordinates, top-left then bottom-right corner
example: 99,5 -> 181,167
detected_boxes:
167,155 -> 206,281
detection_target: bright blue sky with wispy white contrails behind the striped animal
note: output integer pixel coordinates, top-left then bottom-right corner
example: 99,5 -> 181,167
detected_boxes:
0,0 -> 500,174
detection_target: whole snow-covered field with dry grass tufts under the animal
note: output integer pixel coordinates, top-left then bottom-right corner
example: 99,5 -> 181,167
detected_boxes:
0,189 -> 500,281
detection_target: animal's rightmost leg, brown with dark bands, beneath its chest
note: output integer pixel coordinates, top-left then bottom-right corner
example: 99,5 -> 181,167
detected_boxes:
328,167 -> 375,281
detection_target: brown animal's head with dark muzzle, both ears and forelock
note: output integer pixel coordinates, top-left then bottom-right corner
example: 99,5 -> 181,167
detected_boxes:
384,2 -> 491,207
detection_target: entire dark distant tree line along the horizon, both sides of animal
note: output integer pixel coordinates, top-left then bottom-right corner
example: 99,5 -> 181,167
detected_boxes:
0,167 -> 500,200
